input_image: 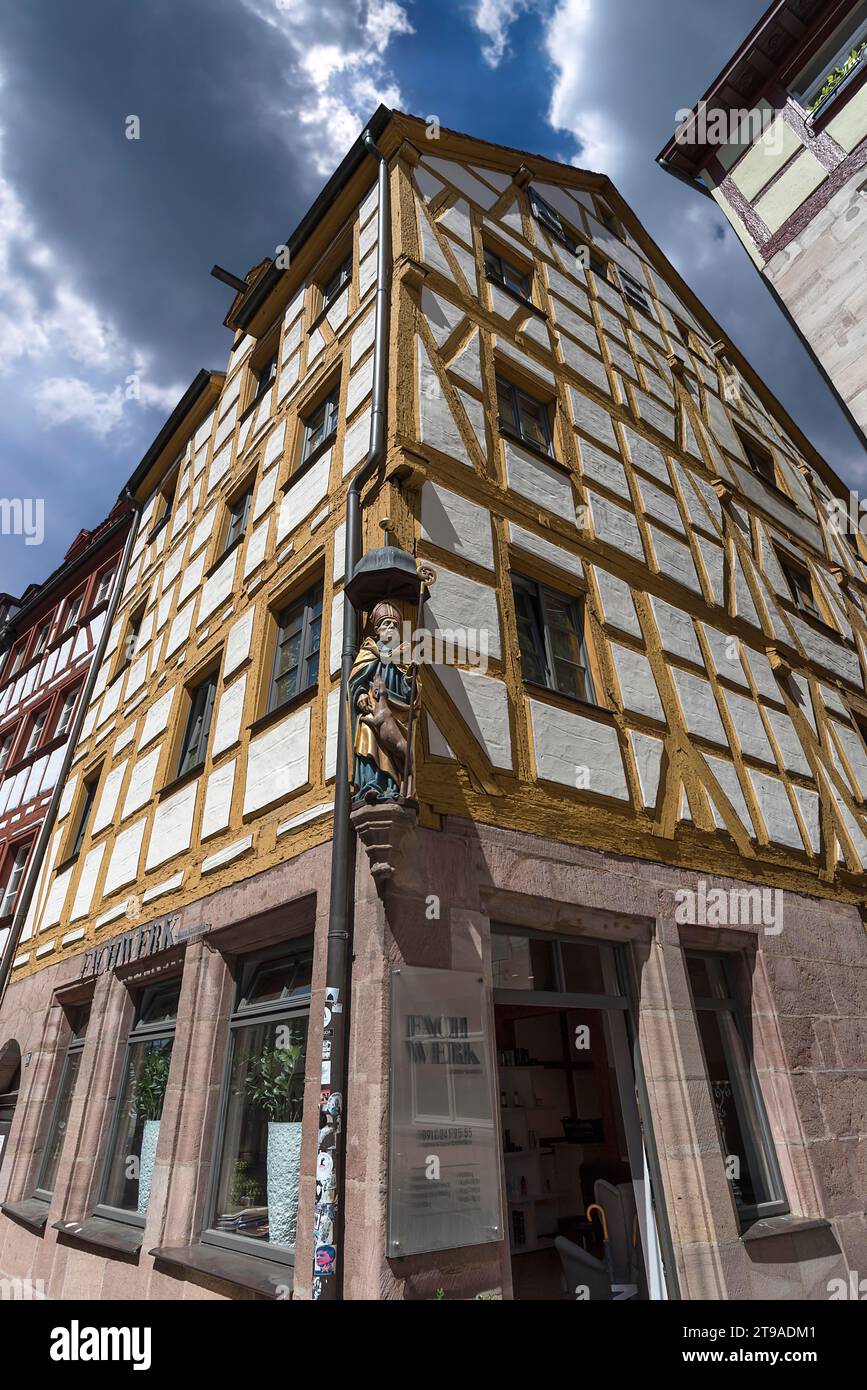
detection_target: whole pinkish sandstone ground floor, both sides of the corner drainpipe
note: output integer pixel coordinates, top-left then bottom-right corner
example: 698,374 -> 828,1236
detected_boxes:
0,809 -> 867,1301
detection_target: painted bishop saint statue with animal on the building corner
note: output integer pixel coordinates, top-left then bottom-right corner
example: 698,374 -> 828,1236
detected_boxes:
349,603 -> 411,805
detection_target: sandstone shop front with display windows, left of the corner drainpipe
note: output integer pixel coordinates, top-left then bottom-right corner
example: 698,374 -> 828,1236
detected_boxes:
0,852 -> 332,1300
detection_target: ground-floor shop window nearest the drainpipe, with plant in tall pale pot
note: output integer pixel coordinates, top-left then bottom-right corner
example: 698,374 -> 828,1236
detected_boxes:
201,938 -> 313,1262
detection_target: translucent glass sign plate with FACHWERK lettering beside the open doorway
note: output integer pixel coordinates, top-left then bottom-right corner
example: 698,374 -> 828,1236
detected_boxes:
388,966 -> 503,1257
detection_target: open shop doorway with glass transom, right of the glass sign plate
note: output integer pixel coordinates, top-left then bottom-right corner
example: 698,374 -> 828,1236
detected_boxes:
492,927 -> 666,1301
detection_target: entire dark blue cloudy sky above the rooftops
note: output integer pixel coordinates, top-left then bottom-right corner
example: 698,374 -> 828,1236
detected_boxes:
0,0 -> 867,594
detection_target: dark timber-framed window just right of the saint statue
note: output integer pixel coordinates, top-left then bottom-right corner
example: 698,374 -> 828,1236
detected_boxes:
511,574 -> 596,703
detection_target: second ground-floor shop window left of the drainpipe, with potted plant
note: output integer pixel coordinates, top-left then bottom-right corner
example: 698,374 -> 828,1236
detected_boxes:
96,980 -> 181,1226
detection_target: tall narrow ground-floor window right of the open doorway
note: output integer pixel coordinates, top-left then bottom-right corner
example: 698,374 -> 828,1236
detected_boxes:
686,951 -> 789,1222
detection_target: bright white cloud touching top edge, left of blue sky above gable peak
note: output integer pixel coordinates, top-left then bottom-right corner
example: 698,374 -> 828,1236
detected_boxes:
242,0 -> 414,175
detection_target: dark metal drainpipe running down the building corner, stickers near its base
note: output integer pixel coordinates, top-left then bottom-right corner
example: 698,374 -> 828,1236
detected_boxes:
313,131 -> 392,1301
